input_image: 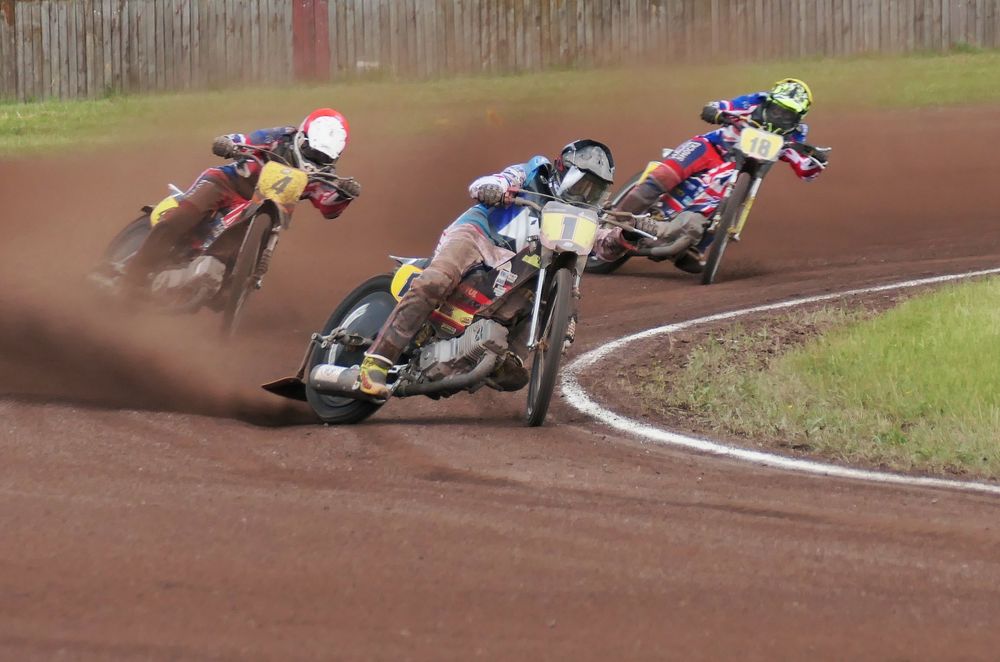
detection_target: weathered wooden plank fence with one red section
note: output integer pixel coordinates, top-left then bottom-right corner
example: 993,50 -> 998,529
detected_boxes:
0,0 -> 1000,100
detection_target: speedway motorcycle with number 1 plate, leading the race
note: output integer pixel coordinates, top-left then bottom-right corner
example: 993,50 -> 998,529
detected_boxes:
264,191 -> 598,426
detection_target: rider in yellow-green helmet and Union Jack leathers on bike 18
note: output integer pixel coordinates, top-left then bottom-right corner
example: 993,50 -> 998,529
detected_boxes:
594,78 -> 829,273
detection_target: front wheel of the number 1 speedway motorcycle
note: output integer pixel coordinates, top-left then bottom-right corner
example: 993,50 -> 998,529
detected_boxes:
527,269 -> 573,427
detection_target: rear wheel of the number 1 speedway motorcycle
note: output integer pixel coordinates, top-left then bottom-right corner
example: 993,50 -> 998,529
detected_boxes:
303,274 -> 396,424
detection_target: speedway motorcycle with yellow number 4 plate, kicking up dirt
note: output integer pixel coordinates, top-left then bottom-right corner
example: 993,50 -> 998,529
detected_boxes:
90,147 -> 358,337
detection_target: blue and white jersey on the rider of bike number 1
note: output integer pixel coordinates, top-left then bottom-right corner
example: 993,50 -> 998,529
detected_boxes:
451,156 -> 555,251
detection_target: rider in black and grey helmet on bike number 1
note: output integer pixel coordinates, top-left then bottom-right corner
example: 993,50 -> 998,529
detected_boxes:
358,139 -> 615,399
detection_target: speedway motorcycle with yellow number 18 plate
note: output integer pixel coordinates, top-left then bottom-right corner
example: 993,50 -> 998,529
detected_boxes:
586,113 -> 828,285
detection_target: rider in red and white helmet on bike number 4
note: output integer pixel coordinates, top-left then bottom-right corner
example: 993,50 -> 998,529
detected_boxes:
124,108 -> 361,293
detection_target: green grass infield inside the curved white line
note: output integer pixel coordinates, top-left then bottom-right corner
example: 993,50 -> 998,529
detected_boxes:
629,279 -> 1000,478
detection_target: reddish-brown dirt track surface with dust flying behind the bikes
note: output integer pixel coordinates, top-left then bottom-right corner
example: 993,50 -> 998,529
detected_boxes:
0,109 -> 1000,660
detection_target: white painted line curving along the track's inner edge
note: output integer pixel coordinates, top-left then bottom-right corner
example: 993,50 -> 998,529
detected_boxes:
562,268 -> 1000,494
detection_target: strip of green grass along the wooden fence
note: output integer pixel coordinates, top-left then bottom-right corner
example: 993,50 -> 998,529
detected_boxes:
0,51 -> 1000,157
